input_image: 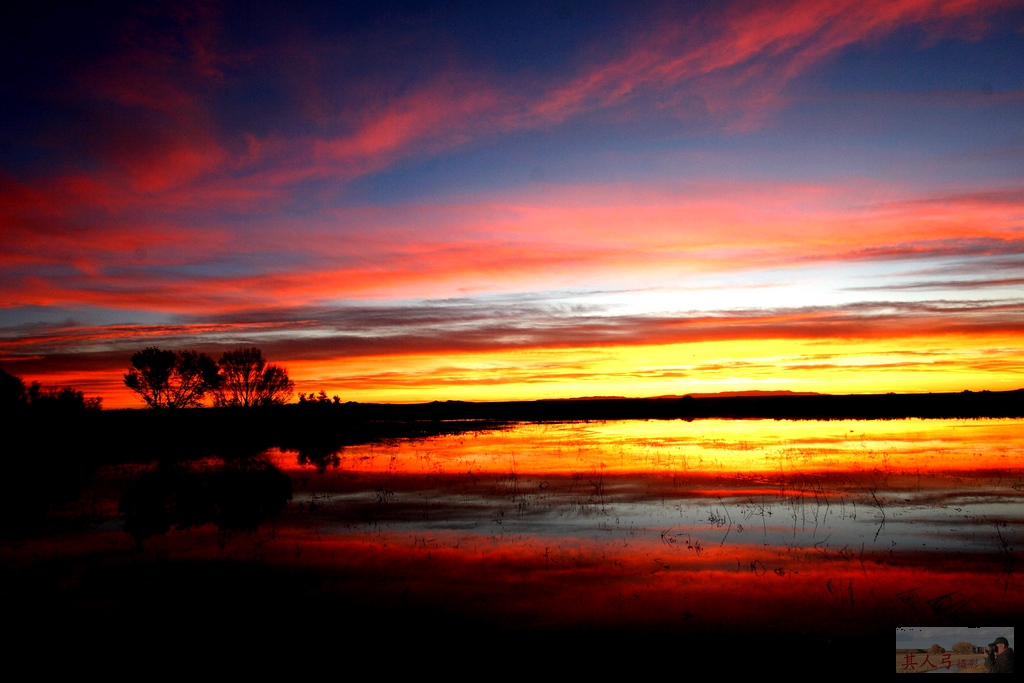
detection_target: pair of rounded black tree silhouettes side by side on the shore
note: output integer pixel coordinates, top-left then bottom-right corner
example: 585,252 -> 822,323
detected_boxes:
124,346 -> 295,409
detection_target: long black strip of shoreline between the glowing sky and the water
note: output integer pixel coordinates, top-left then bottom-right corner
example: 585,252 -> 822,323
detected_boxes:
24,389 -> 1024,464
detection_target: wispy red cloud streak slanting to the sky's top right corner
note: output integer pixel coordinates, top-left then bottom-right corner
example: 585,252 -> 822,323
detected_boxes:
529,0 -> 1014,127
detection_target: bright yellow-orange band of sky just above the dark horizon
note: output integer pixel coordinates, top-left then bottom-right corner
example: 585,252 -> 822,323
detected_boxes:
290,336 -> 1024,409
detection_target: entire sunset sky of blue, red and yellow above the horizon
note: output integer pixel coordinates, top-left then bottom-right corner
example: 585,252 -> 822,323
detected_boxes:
0,0 -> 1024,408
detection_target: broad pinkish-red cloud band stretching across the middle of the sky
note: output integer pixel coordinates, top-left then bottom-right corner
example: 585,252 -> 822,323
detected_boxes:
0,177 -> 1024,313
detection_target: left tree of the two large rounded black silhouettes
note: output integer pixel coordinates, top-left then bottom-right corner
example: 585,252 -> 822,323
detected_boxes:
125,346 -> 220,408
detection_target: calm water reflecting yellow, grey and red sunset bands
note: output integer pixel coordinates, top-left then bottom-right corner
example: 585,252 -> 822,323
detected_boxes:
25,420 -> 1024,643
